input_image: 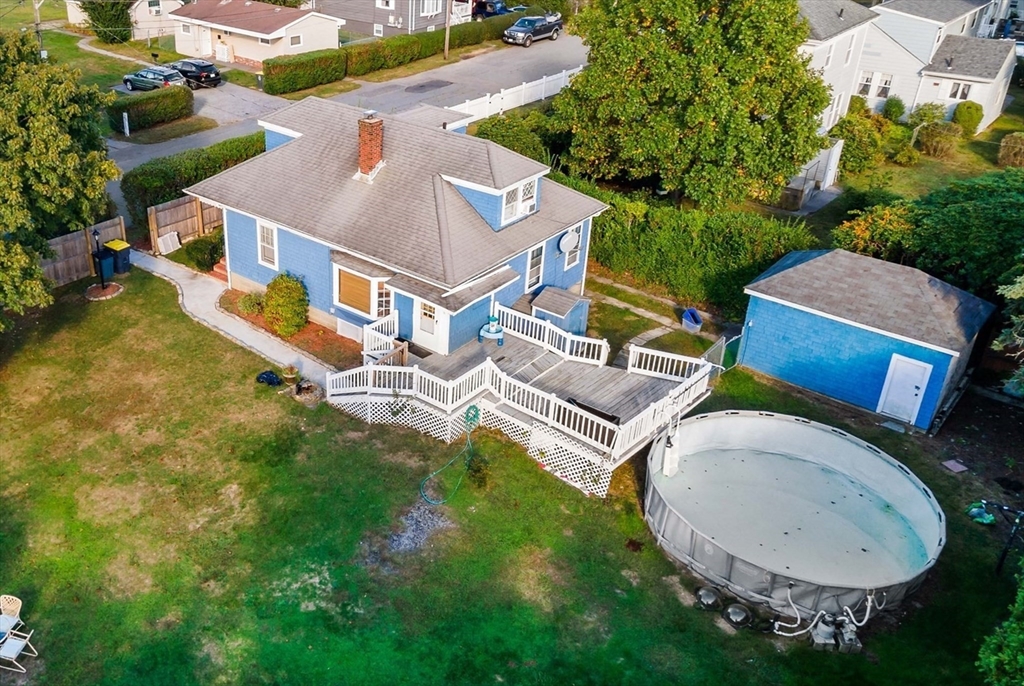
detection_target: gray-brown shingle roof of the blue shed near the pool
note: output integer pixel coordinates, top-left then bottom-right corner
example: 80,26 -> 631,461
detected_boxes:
745,250 -> 994,355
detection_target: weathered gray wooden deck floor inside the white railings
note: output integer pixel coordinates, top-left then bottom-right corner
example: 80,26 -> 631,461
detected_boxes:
409,336 -> 677,422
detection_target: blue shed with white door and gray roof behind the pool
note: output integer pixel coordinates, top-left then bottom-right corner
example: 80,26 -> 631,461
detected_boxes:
739,250 -> 994,429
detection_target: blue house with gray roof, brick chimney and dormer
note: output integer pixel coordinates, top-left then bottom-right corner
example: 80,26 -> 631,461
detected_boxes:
186,97 -> 605,355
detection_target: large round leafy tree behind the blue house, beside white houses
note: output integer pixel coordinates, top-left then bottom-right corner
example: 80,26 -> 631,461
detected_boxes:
554,0 -> 829,210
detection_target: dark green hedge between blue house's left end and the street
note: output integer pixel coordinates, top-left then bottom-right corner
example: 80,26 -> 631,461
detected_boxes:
121,133 -> 264,227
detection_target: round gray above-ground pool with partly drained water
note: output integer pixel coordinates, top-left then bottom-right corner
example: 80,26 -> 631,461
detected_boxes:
645,412 -> 946,616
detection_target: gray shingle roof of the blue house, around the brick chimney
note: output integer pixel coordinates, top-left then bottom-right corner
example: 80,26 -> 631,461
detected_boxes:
193,98 -> 605,288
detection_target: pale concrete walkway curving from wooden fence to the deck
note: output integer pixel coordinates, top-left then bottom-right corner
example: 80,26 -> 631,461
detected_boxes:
131,250 -> 337,387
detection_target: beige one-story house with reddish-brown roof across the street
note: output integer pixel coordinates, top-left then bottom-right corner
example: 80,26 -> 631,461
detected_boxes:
171,0 -> 344,68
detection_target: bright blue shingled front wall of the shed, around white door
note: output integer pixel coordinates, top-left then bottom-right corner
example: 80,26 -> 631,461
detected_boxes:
739,297 -> 951,429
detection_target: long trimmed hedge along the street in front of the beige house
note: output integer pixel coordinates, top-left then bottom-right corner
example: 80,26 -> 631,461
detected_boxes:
263,8 -> 543,95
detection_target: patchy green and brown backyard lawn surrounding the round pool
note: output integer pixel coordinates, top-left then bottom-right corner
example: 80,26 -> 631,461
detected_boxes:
0,270 -> 1011,686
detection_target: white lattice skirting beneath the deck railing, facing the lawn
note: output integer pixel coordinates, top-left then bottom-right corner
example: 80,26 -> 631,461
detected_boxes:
331,395 -> 612,498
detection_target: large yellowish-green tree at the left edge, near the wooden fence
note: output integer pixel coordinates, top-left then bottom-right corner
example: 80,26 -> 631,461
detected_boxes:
0,30 -> 119,253
